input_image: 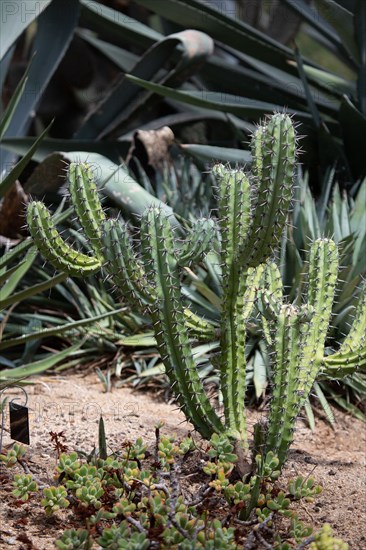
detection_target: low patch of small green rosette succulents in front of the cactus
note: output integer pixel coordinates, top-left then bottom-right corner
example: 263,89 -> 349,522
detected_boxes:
3,427 -> 347,550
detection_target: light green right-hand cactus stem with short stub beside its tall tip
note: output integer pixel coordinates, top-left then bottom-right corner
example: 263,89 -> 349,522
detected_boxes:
260,239 -> 338,465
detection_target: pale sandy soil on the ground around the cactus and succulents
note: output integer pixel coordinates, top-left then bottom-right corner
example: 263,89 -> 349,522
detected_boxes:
0,373 -> 366,550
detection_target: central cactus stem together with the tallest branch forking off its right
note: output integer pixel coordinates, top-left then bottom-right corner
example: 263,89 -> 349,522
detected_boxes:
213,114 -> 296,446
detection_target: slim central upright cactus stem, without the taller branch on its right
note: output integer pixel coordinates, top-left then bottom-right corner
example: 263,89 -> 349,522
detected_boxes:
214,165 -> 254,446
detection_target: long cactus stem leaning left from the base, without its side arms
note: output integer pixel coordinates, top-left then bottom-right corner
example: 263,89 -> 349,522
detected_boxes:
141,208 -> 224,437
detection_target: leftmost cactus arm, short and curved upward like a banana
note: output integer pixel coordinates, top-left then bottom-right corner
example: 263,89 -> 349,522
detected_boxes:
27,201 -> 101,277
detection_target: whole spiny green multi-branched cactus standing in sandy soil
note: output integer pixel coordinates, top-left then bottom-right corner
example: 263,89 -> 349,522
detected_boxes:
28,113 -> 366,473
